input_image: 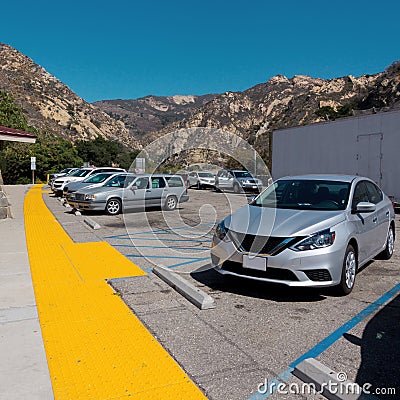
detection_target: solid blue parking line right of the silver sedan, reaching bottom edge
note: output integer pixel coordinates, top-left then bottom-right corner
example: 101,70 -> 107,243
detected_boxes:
248,283 -> 400,400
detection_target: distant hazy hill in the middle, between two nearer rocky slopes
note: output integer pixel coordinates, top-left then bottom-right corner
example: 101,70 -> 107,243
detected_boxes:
93,94 -> 216,142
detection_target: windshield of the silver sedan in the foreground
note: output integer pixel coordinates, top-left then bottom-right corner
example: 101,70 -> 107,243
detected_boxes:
251,179 -> 350,211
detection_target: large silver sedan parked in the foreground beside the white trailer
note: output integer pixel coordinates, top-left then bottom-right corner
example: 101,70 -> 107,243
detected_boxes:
211,175 -> 395,294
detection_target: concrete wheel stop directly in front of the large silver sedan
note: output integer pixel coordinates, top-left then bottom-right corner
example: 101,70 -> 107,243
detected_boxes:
153,266 -> 215,310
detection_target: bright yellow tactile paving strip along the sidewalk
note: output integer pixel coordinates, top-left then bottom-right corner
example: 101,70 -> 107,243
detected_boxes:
24,186 -> 206,400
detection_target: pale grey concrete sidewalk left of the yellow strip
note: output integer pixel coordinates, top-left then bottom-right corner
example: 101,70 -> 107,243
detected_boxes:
0,185 -> 54,400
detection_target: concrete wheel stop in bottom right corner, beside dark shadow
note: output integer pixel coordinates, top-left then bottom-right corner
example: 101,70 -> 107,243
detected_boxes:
293,358 -> 376,400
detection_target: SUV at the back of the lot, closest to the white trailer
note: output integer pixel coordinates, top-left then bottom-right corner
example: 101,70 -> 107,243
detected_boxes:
215,169 -> 262,193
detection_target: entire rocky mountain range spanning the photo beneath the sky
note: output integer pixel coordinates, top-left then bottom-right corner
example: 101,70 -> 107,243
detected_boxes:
0,44 -> 400,166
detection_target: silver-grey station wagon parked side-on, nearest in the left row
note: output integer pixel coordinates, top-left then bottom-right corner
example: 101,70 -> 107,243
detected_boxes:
67,174 -> 189,215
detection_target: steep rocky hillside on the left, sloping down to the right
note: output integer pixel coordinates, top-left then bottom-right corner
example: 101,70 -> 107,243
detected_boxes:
0,43 -> 140,148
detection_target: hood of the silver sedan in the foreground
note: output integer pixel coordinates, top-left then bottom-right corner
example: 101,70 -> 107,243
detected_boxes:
224,205 -> 346,237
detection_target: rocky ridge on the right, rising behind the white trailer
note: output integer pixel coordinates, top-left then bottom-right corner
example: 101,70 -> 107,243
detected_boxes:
150,62 -> 400,164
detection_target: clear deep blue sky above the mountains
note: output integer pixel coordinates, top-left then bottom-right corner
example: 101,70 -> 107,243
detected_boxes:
0,0 -> 400,102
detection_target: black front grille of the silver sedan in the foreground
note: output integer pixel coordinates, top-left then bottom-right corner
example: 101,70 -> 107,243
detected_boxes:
229,231 -> 296,255
